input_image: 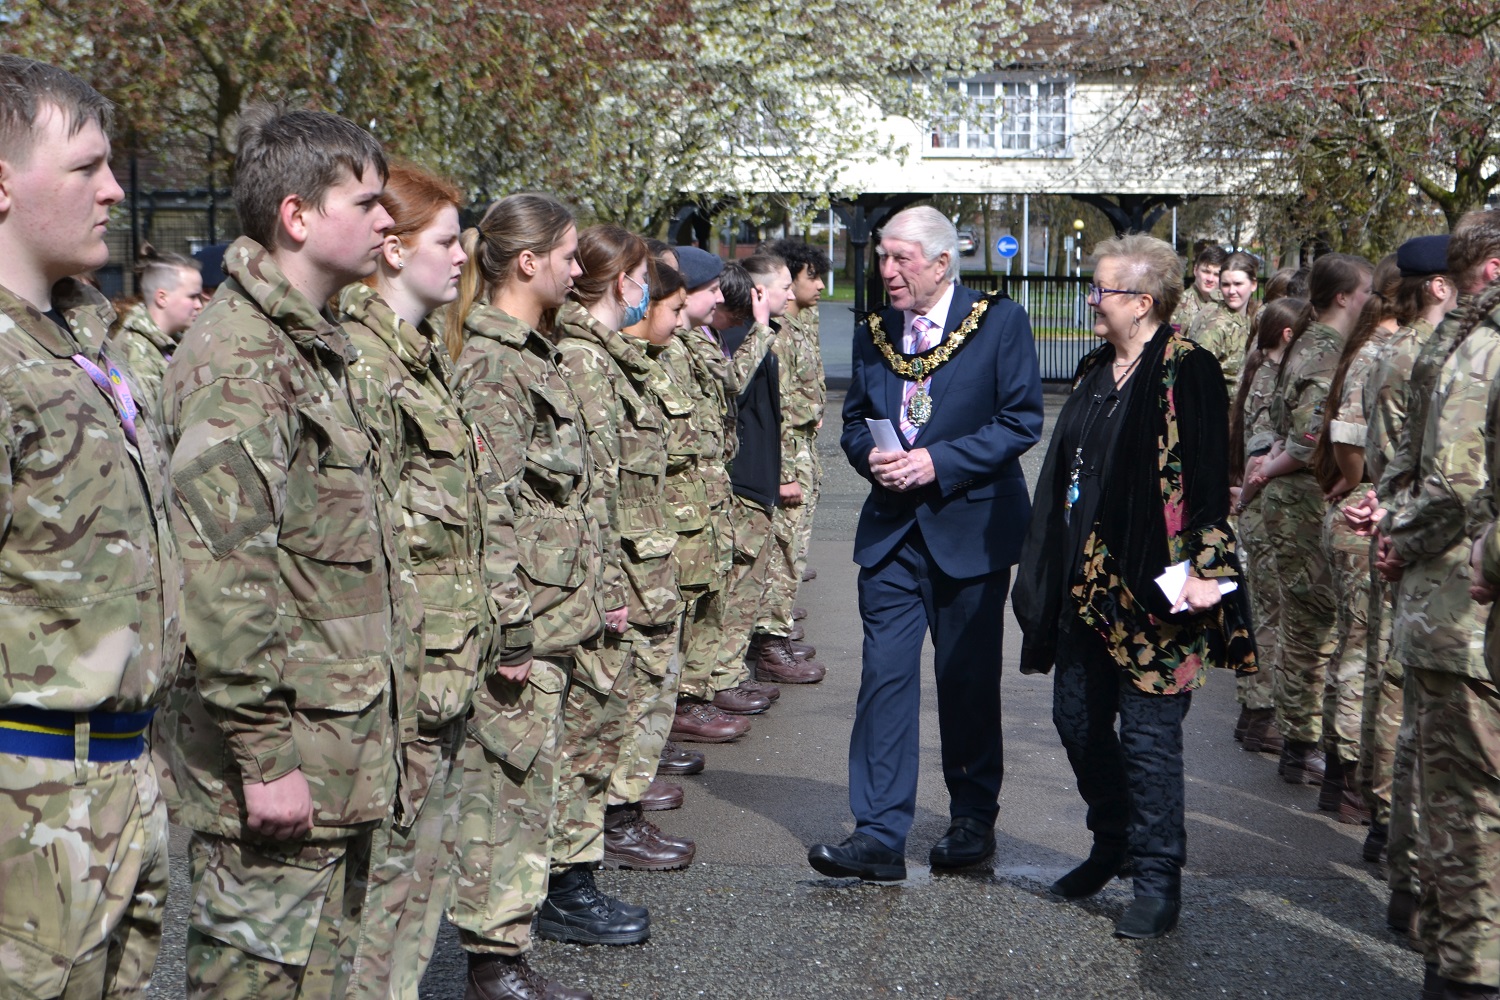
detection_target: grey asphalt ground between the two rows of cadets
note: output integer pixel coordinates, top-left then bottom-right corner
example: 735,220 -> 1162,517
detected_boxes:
150,393 -> 1422,1000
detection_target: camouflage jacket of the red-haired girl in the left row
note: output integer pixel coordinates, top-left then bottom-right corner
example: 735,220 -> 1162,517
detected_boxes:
339,283 -> 495,739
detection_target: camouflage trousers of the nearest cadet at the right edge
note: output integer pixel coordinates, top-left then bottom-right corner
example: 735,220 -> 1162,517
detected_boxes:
1412,669 -> 1500,987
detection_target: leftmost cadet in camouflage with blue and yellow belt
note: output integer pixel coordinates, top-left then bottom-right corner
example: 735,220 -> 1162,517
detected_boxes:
0,55 -> 183,1000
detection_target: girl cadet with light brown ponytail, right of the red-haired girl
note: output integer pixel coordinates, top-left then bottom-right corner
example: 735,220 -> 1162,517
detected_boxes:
447,195 -> 630,1000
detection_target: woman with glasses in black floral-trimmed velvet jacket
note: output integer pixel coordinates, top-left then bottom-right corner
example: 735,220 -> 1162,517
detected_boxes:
1014,235 -> 1254,939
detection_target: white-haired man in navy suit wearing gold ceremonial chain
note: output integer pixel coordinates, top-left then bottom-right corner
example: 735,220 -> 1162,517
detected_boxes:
807,207 -> 1043,882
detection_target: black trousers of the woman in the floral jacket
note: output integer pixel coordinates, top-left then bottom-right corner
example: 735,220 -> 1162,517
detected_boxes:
1052,621 -> 1193,900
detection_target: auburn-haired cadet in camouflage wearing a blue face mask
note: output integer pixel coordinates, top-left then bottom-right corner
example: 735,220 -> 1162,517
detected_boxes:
552,225 -> 693,871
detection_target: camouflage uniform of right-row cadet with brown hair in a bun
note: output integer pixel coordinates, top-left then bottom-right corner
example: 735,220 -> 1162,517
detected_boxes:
1262,322 -> 1343,742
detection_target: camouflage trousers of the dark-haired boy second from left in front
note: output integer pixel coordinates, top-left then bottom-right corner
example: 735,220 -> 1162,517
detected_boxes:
188,829 -> 372,1000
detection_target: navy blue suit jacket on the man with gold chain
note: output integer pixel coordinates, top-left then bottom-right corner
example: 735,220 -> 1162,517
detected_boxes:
840,285 -> 1043,579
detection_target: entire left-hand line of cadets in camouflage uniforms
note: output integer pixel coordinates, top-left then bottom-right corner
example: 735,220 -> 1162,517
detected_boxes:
0,55 -> 830,1000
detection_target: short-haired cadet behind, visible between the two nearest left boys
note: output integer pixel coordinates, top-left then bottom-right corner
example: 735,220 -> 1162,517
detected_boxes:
111,246 -> 204,421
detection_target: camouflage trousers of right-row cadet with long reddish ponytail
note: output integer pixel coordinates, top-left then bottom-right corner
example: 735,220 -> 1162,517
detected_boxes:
1323,504 -> 1370,768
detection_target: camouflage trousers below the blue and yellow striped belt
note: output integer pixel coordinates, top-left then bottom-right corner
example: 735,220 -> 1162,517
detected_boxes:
0,753 -> 167,1000
